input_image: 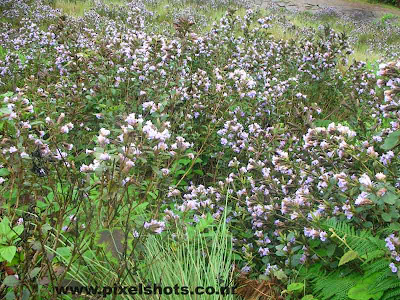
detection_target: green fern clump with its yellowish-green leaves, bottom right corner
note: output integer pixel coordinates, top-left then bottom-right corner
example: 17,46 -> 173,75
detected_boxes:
305,218 -> 400,300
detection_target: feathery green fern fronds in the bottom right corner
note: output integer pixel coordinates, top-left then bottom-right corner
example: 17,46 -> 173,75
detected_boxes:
309,218 -> 400,300
